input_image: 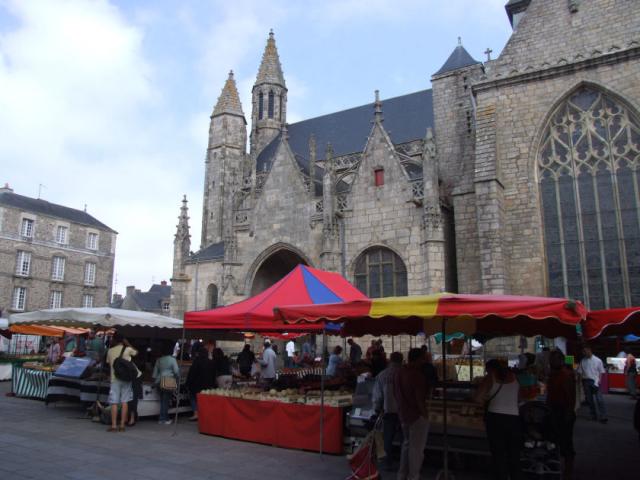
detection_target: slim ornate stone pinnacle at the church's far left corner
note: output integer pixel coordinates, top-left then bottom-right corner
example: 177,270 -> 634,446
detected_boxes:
170,195 -> 191,318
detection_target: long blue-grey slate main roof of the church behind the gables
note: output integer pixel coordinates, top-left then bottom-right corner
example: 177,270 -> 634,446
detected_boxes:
256,90 -> 434,176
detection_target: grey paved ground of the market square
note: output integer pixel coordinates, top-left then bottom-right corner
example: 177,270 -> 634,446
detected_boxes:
0,382 -> 640,480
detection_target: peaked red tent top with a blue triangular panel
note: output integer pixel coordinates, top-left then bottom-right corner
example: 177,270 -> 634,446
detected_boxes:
184,265 -> 367,332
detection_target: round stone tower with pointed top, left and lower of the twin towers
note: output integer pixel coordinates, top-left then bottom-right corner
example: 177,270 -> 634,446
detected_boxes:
201,71 -> 247,248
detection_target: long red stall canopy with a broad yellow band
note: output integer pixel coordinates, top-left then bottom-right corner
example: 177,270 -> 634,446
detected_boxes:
276,293 -> 587,338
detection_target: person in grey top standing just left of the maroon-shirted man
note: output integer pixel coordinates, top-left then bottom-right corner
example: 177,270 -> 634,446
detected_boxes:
372,347 -> 403,470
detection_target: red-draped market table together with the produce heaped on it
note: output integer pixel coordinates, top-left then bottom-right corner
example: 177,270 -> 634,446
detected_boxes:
198,375 -> 353,454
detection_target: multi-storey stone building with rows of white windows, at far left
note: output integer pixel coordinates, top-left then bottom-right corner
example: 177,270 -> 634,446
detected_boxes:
0,185 -> 117,313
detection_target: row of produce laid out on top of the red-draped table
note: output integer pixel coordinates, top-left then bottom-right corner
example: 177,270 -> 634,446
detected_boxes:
200,386 -> 353,407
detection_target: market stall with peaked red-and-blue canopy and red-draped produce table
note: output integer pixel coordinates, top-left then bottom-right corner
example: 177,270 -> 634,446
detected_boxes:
184,265 -> 366,453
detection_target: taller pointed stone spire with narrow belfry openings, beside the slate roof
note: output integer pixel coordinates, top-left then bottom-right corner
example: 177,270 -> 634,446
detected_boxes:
251,30 -> 287,154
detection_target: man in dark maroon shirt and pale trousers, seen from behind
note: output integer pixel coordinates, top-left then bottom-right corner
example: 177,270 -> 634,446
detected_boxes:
393,348 -> 429,480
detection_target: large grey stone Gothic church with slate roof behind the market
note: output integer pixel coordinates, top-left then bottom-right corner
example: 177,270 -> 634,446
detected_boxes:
171,0 -> 640,338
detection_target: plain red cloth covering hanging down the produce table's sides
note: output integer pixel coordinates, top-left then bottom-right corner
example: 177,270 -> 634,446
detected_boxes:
198,394 -> 343,454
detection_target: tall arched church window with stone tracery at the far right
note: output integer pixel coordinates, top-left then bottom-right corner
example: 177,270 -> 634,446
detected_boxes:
538,86 -> 640,309
